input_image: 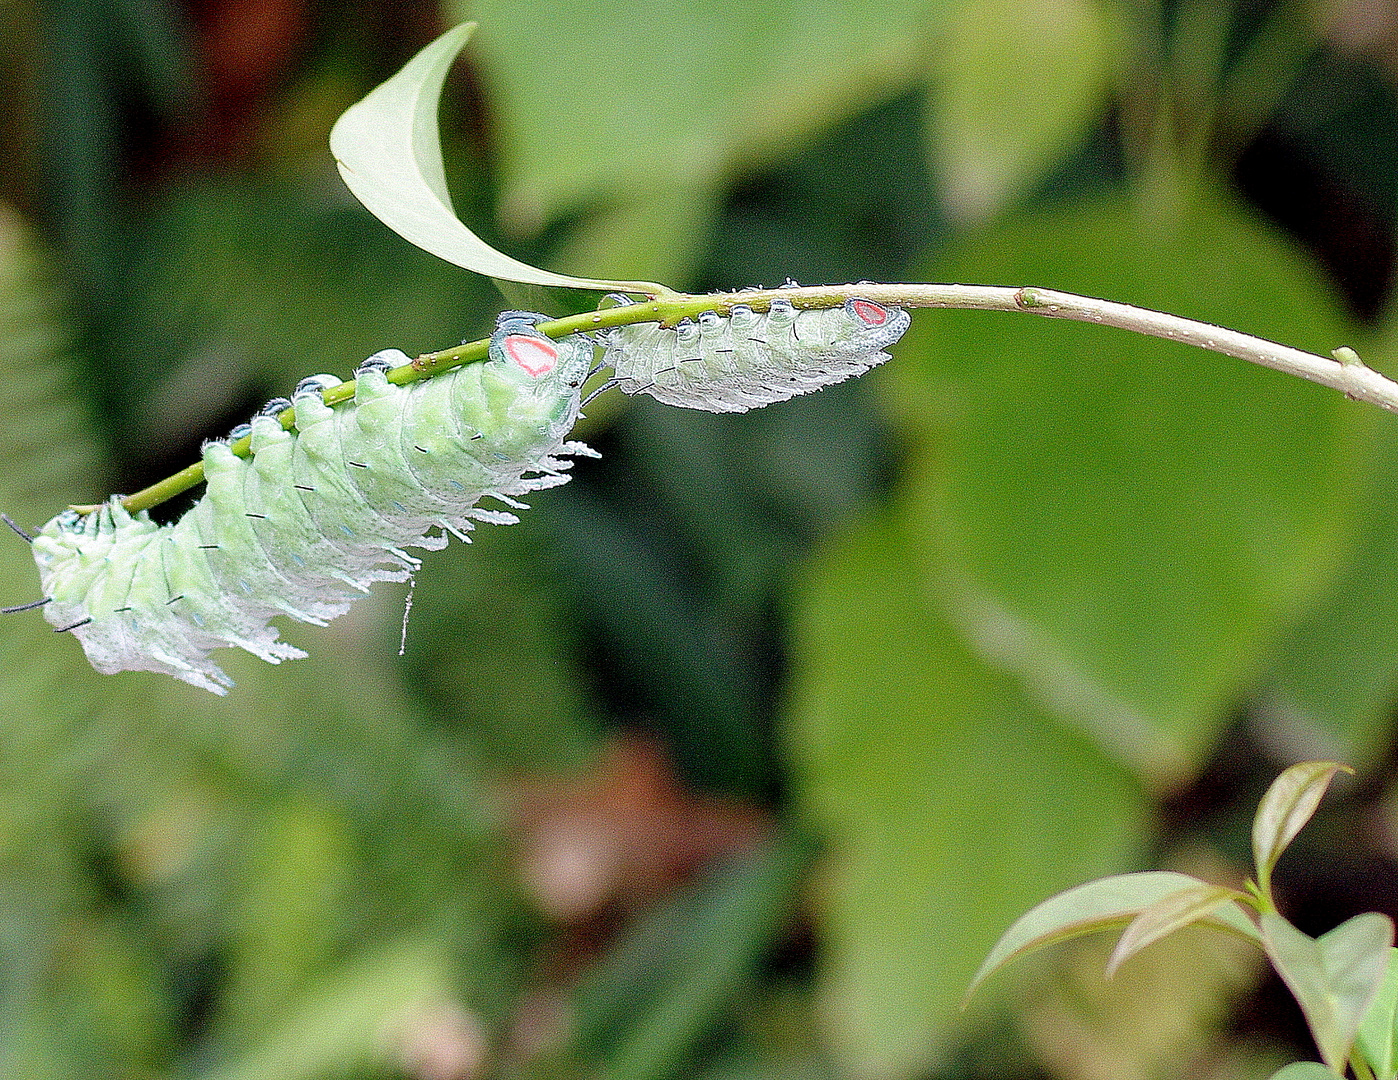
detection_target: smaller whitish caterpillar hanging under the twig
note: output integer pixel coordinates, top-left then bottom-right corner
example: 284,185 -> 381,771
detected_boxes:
601,293 -> 911,412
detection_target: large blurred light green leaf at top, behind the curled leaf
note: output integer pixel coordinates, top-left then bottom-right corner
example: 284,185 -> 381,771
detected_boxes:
458,0 -> 948,232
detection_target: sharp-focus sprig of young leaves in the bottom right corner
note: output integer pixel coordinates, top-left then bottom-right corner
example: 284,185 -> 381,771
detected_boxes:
967,761 -> 1398,1080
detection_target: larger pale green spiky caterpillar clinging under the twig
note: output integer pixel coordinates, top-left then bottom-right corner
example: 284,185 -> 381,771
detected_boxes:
25,312 -> 596,694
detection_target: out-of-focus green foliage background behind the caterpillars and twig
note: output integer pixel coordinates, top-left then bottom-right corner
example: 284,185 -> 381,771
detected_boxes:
0,0 -> 1398,1080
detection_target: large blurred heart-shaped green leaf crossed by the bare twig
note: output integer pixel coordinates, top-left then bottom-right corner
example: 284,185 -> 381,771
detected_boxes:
879,196 -> 1378,787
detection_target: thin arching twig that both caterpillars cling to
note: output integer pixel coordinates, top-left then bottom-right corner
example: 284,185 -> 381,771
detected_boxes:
103,282 -> 1398,513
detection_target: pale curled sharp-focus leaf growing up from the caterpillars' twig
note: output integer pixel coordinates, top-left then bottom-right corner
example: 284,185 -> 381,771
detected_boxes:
330,22 -> 667,292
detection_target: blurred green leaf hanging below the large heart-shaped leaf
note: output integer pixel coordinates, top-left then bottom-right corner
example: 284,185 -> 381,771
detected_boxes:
787,514 -> 1146,1076
